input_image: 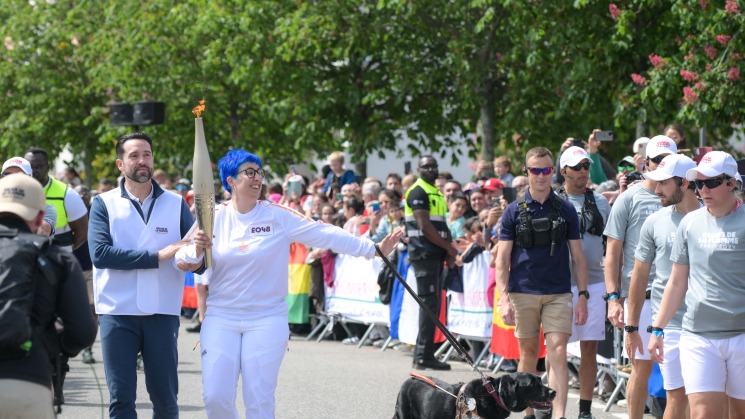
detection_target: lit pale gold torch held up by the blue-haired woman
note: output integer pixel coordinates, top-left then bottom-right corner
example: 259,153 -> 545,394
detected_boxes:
192,100 -> 215,268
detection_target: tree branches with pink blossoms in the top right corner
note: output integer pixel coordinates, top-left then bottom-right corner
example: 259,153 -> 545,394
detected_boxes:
627,0 -> 745,143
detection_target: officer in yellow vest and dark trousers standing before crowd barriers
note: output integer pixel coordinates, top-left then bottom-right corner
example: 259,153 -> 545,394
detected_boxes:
404,156 -> 457,370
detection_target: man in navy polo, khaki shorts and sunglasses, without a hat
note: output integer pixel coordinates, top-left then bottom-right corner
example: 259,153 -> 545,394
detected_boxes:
496,147 -> 589,418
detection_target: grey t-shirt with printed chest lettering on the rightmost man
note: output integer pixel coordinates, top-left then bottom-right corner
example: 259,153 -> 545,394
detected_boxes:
670,206 -> 745,339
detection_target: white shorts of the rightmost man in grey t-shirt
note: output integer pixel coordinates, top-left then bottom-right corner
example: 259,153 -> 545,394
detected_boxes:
680,332 -> 745,400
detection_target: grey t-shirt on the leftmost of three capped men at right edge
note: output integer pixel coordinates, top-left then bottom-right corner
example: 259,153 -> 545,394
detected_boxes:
604,183 -> 662,295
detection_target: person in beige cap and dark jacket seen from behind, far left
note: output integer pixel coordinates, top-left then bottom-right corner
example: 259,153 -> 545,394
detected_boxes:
0,174 -> 96,419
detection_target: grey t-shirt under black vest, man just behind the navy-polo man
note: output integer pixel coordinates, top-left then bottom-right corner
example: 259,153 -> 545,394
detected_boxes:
567,191 -> 610,285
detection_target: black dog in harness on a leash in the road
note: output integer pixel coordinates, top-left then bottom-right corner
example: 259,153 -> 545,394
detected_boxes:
393,372 -> 556,419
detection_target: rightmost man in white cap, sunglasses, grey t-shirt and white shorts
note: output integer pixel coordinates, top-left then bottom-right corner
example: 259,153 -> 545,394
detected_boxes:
648,151 -> 745,419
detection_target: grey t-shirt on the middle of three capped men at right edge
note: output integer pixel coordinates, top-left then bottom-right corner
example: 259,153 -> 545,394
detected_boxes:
634,205 -> 686,329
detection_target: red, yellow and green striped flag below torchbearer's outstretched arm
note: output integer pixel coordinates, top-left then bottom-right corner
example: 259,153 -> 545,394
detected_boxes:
285,243 -> 310,324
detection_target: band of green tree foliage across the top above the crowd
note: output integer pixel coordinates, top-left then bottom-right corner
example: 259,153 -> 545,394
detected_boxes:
0,0 -> 745,185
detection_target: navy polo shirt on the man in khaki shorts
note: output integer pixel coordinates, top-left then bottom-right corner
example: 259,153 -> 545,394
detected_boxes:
499,191 -> 580,295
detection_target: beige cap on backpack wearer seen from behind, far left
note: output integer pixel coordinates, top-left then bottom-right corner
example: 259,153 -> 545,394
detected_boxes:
0,173 -> 47,221
